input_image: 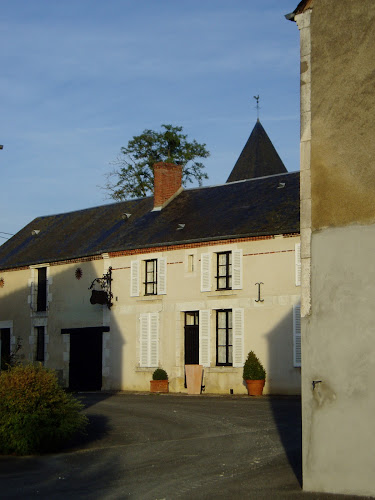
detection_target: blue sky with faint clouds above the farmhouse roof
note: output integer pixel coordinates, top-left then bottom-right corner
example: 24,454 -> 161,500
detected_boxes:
0,0 -> 299,244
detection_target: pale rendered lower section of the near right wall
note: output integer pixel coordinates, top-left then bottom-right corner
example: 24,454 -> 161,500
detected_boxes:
302,225 -> 375,495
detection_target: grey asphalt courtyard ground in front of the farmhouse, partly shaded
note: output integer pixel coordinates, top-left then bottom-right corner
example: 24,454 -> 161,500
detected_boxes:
0,393 -> 370,500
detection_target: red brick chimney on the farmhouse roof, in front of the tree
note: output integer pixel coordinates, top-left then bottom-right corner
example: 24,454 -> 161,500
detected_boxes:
154,162 -> 182,210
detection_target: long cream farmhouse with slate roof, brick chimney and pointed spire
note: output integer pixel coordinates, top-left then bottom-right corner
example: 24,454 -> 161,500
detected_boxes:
0,120 -> 301,394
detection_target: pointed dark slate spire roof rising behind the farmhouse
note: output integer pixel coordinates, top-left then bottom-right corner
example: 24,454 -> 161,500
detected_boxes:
227,119 -> 287,182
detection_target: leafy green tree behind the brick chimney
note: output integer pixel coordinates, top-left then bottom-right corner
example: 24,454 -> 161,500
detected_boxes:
103,125 -> 210,201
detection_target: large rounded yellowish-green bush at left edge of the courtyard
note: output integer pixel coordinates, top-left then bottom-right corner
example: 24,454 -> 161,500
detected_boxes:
0,365 -> 88,455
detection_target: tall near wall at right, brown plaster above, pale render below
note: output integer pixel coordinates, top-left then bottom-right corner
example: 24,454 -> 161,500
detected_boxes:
295,0 -> 375,496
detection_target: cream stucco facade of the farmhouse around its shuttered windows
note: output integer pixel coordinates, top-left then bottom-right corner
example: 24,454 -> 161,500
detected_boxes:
0,236 -> 300,394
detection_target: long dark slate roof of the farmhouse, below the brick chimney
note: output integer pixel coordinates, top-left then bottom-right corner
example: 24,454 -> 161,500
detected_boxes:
0,172 -> 300,269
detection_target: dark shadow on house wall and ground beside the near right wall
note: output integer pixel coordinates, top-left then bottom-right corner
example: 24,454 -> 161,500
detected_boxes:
267,310 -> 302,487
